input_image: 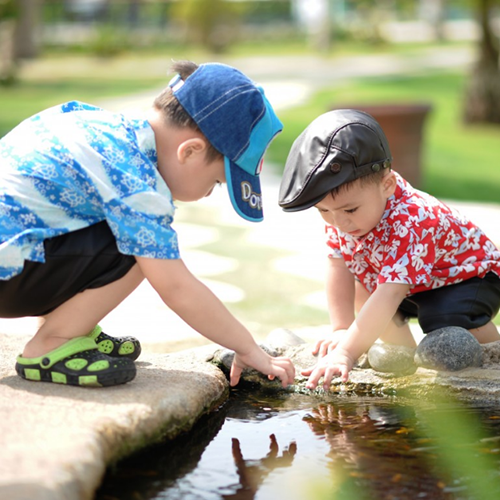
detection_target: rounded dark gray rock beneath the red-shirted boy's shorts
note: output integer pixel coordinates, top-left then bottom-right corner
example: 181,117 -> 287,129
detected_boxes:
415,326 -> 483,371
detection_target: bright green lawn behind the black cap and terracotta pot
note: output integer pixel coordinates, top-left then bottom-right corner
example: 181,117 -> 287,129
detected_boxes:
269,73 -> 500,202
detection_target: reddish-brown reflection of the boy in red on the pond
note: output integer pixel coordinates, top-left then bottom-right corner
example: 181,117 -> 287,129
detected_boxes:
304,404 -> 453,500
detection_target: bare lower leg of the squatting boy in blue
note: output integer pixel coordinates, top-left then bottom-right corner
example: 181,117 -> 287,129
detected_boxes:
23,264 -> 144,358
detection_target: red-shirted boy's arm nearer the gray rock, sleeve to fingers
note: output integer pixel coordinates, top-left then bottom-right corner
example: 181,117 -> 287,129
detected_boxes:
302,283 -> 410,390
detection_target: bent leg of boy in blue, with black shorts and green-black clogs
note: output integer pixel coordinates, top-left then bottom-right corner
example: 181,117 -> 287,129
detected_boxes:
9,222 -> 143,387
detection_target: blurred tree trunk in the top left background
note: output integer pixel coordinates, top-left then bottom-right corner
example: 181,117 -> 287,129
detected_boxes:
14,0 -> 42,59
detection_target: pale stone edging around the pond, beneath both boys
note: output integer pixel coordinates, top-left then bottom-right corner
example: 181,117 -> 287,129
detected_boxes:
0,331 -> 500,500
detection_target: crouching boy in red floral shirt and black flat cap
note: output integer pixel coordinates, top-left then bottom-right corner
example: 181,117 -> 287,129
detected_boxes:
280,109 -> 500,388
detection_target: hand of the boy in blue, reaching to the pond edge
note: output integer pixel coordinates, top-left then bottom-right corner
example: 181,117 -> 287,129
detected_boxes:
229,345 -> 295,388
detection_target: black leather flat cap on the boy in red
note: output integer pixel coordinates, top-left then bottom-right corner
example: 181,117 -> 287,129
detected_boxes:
279,109 -> 392,212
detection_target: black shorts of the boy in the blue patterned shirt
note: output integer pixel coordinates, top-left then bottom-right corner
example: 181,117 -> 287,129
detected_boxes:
0,222 -> 135,318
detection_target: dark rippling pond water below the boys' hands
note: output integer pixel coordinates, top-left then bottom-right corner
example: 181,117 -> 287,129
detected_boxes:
95,391 -> 500,500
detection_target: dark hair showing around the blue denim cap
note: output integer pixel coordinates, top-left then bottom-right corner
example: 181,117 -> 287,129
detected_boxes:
153,61 -> 223,163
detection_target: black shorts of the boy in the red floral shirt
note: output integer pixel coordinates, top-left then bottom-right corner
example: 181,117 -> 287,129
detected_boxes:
398,273 -> 500,333
